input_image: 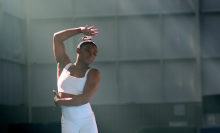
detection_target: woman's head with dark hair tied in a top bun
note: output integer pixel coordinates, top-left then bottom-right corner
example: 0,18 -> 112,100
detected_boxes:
77,36 -> 98,64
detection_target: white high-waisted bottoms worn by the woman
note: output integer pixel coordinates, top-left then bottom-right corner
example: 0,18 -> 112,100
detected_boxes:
61,104 -> 98,133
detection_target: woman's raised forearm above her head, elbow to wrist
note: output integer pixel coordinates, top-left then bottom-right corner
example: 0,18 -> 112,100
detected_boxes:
54,27 -> 82,42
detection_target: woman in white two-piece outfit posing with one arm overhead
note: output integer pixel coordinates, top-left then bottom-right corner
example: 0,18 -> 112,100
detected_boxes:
53,25 -> 101,133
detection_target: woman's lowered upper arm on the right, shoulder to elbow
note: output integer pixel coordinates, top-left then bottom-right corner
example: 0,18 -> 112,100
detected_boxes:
83,69 -> 101,102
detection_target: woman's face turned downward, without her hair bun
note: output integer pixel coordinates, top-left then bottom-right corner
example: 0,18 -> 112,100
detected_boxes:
77,44 -> 97,64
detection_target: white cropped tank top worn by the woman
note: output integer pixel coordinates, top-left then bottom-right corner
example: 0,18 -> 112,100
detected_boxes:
57,63 -> 90,95
